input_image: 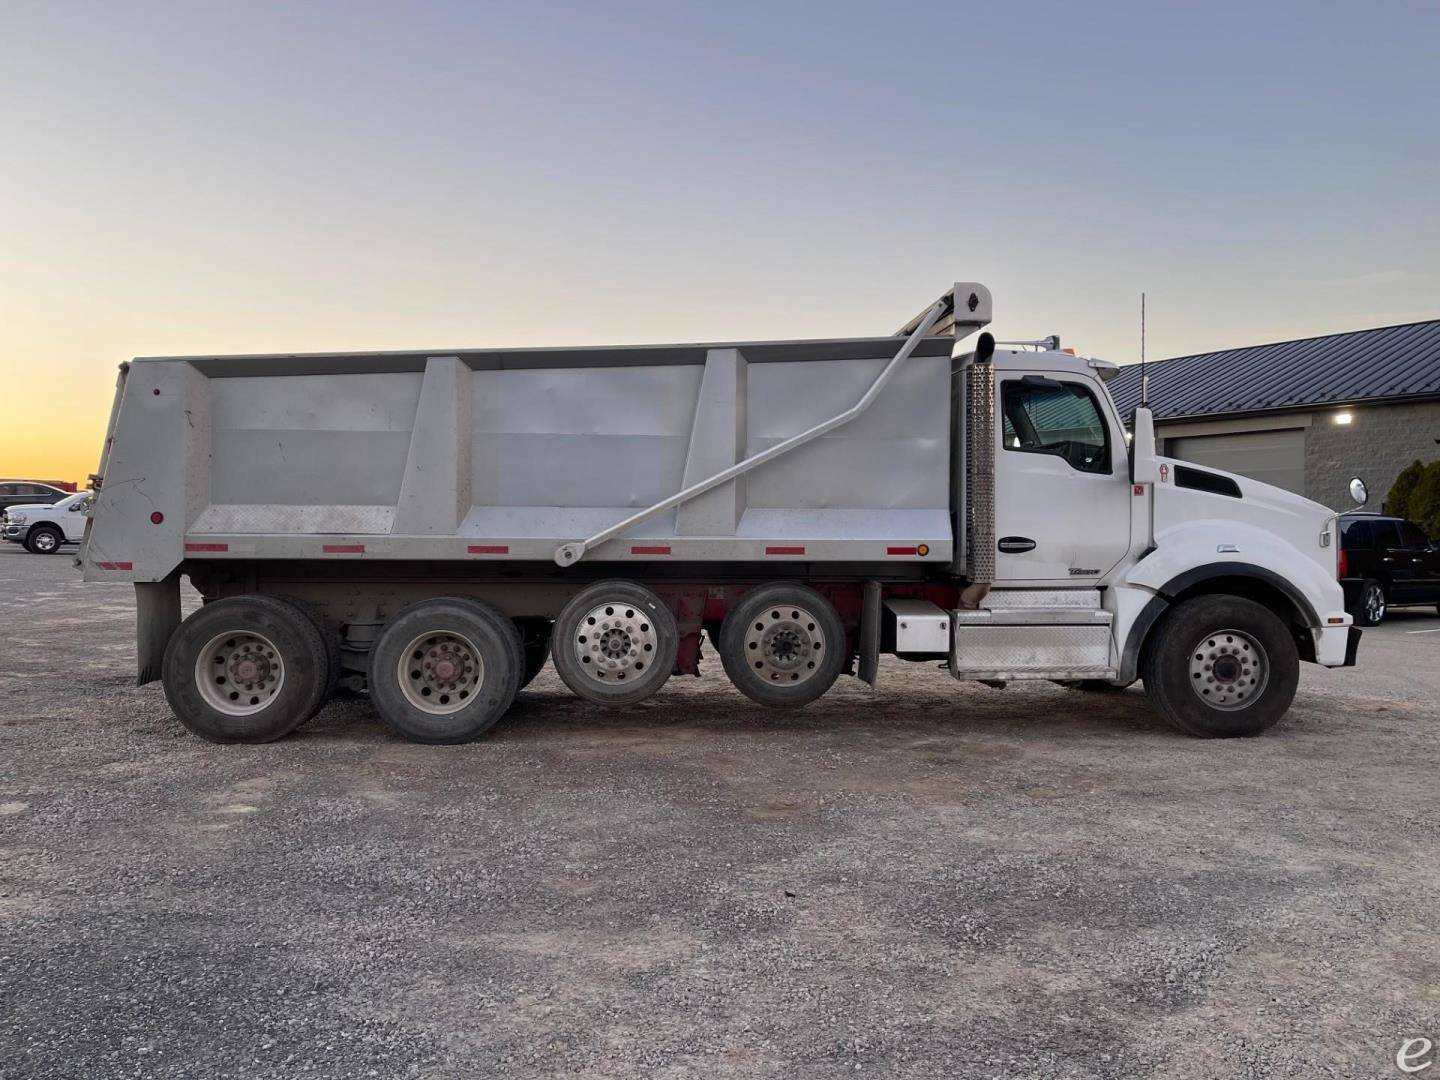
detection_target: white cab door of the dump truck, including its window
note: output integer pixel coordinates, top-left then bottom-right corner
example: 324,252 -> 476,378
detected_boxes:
995,370 -> 1130,586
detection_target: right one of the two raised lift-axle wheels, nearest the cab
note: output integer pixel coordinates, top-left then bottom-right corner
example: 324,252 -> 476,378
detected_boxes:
720,585 -> 845,708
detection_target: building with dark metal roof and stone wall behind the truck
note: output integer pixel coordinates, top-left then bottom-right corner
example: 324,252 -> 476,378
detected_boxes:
1110,320 -> 1440,508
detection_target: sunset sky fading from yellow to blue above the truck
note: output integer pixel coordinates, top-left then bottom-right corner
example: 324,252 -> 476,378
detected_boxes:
0,0 -> 1440,480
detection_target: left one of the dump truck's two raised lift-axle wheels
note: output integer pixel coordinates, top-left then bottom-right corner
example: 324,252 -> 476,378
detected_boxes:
550,580 -> 680,706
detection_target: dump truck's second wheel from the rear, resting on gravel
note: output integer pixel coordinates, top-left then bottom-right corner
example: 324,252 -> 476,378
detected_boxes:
369,598 -> 523,744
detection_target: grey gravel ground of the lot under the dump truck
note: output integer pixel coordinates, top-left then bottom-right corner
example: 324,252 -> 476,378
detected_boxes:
0,544 -> 1440,1080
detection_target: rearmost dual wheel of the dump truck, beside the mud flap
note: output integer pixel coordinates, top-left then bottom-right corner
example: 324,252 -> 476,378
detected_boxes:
164,596 -> 330,743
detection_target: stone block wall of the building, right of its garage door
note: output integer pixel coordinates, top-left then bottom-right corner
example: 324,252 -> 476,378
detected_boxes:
1305,402 -> 1440,510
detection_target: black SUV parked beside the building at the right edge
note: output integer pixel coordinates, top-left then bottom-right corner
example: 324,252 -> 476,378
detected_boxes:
1339,513 -> 1440,626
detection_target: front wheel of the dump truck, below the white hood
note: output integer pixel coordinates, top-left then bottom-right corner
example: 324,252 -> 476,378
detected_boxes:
1142,596 -> 1300,739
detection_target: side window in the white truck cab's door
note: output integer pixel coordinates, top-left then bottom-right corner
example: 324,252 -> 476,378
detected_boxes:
1001,376 -> 1110,472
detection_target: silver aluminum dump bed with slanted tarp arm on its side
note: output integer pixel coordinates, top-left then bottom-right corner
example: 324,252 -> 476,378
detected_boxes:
82,284 -> 989,582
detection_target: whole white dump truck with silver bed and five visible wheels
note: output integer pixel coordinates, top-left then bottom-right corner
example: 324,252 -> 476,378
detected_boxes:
81,282 -> 1359,743
